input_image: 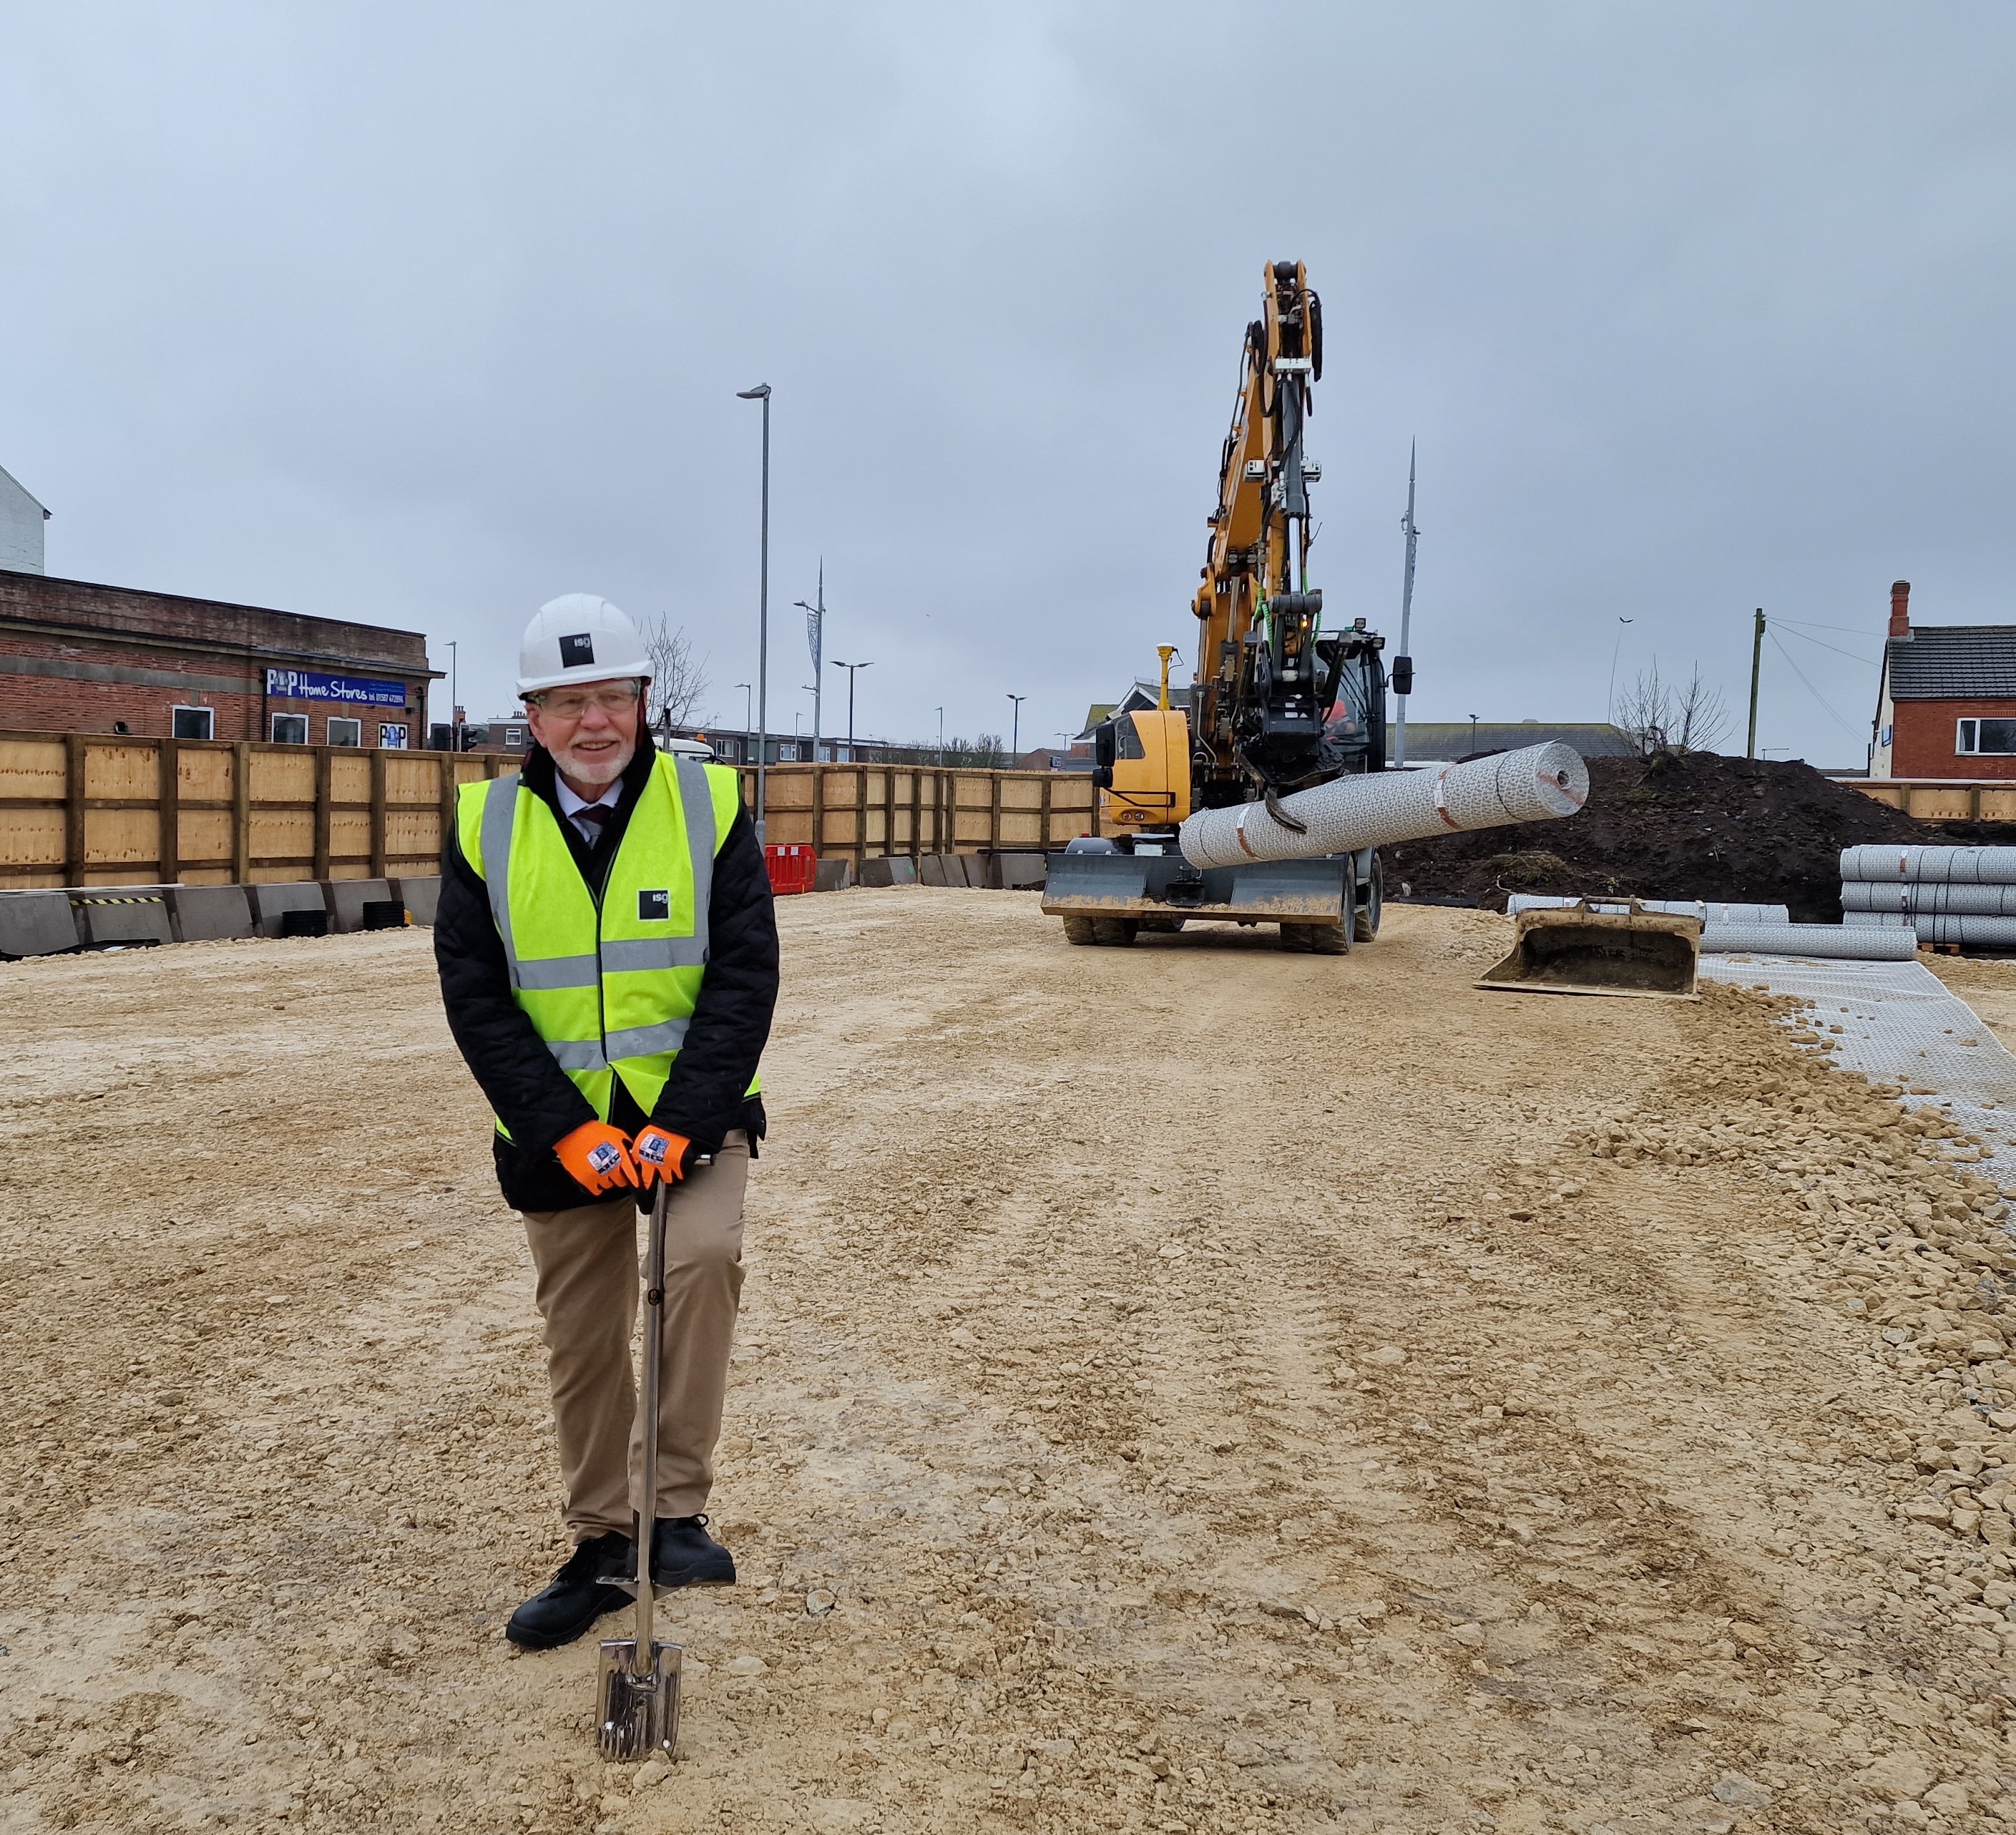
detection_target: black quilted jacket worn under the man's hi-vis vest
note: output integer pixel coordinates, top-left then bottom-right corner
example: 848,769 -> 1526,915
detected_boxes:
434,746 -> 776,1210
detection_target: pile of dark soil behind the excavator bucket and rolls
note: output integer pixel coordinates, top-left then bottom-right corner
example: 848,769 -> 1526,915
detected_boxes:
1381,752 -> 1927,924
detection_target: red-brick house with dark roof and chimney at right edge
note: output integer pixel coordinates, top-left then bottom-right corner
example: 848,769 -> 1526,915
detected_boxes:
1869,581 -> 2016,778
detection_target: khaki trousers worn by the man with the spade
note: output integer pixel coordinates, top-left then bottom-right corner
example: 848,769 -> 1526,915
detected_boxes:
524,1129 -> 750,1542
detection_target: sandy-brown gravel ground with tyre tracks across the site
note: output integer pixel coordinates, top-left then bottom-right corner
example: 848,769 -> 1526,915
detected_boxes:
0,889 -> 2016,1835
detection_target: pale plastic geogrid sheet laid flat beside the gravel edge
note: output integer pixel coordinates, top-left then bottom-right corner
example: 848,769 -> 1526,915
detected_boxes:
1701,956 -> 2016,1190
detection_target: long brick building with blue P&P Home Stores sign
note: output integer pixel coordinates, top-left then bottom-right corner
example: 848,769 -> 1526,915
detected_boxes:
0,571 -> 439,748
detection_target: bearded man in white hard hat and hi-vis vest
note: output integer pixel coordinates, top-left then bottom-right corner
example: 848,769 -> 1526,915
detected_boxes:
434,593 -> 776,1650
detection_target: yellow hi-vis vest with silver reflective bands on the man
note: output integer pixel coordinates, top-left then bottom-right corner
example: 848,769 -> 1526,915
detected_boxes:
456,752 -> 762,1137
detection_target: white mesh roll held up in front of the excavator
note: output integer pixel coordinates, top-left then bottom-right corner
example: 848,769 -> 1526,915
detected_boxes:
1178,740 -> 1589,867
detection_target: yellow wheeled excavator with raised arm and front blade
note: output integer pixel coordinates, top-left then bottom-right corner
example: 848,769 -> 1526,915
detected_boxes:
1042,262 -> 1411,954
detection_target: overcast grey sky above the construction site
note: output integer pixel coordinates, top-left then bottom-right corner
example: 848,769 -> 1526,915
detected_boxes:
0,0 -> 2016,764
